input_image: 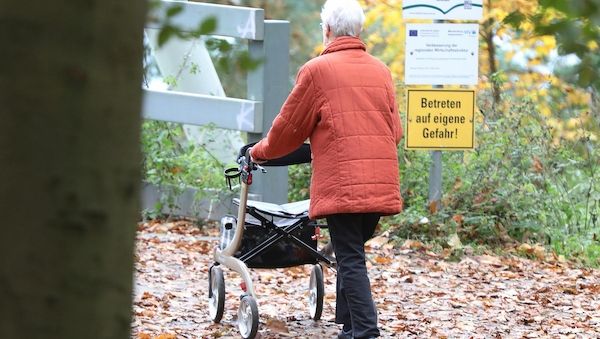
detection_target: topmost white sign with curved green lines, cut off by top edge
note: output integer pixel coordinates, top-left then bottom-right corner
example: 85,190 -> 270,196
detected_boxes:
402,0 -> 483,20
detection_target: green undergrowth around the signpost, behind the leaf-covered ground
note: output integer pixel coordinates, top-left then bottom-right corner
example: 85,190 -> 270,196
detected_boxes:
387,95 -> 600,265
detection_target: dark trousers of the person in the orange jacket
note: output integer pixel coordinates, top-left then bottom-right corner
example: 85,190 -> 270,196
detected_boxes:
327,213 -> 379,338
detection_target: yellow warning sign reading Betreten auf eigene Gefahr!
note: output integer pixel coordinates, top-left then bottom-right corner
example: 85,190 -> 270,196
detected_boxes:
405,89 -> 475,150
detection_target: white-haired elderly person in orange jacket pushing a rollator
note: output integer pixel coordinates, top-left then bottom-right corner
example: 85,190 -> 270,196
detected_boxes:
251,0 -> 402,338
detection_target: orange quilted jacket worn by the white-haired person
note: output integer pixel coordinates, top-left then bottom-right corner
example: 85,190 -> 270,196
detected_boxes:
252,36 -> 402,219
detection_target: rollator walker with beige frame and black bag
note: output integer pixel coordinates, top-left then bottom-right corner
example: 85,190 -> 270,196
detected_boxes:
208,143 -> 335,338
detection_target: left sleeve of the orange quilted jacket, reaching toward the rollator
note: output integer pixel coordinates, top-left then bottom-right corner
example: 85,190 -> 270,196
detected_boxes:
252,65 -> 319,160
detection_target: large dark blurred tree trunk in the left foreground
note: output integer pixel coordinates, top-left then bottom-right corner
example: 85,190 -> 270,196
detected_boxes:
0,0 -> 146,339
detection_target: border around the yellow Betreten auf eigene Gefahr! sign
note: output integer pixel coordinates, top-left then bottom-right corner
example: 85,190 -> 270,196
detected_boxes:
404,88 -> 476,151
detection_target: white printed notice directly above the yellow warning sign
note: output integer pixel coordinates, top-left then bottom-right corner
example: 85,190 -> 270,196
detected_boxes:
404,24 -> 479,85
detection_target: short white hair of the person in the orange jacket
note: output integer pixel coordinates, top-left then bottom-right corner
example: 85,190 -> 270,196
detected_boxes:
321,0 -> 365,37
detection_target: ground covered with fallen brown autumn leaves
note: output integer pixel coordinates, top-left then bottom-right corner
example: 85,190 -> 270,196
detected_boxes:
132,221 -> 600,339
